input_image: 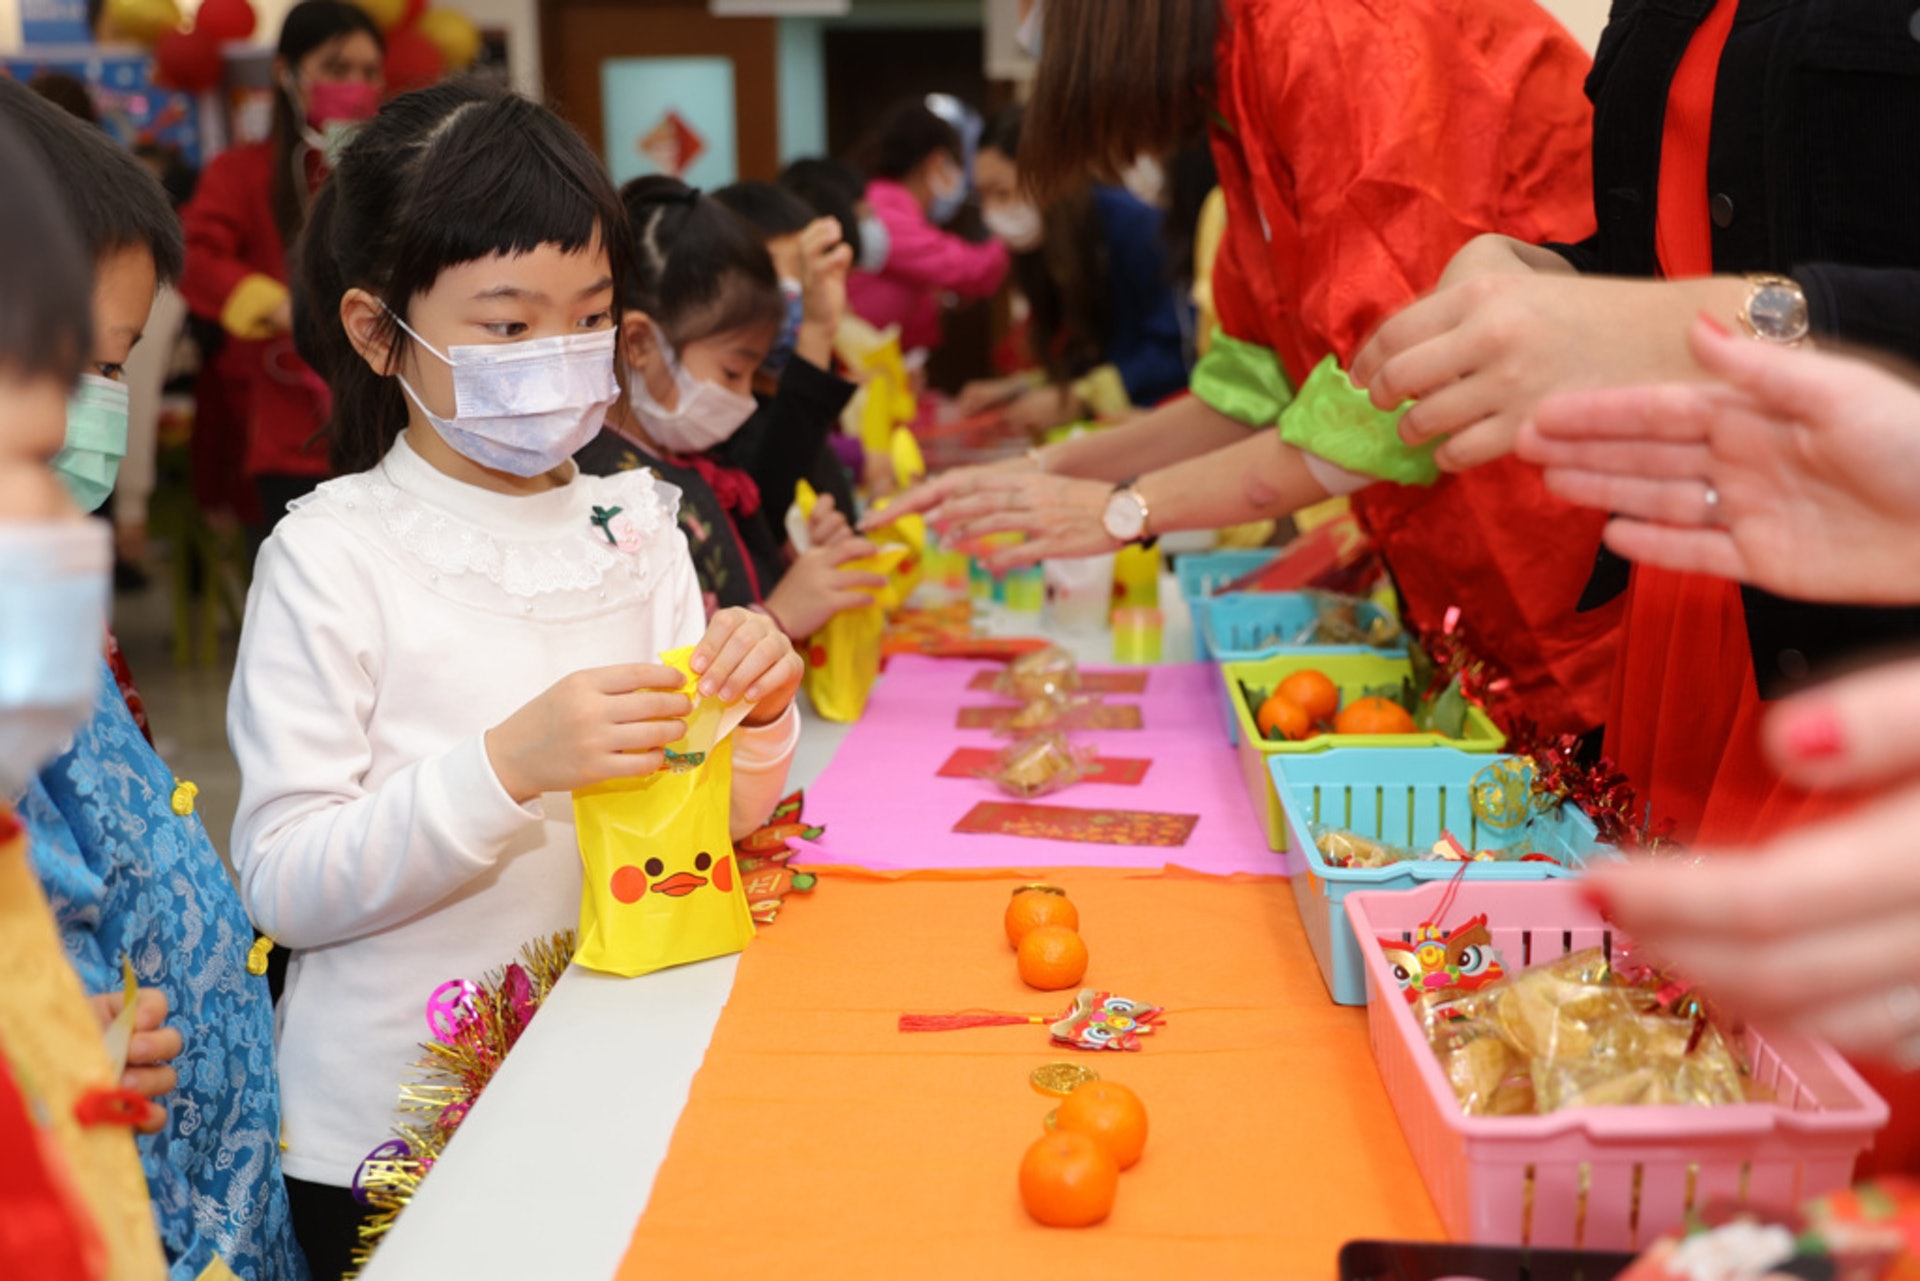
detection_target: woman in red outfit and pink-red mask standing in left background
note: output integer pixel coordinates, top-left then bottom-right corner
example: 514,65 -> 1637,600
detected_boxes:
180,0 -> 386,544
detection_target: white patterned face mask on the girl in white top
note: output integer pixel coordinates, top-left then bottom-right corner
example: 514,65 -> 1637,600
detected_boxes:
394,315 -> 620,476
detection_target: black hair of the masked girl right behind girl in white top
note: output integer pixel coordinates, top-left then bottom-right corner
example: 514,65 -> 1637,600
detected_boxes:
620,175 -> 787,350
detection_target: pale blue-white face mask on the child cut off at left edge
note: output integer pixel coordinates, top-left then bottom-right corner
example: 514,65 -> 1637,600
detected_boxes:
0,520 -> 113,801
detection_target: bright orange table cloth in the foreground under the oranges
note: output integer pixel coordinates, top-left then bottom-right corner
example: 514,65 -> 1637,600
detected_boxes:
618,868 -> 1442,1281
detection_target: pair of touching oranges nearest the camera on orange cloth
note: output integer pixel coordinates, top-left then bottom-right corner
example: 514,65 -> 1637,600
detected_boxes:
1020,1081 -> 1146,1227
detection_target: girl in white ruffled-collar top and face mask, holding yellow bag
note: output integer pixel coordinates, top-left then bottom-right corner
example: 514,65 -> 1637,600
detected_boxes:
228,85 -> 801,1279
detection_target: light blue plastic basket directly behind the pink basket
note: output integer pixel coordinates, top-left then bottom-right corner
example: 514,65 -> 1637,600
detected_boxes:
1269,747 -> 1620,1004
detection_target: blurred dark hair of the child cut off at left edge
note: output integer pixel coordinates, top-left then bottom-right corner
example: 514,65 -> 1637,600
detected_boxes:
0,115 -> 94,386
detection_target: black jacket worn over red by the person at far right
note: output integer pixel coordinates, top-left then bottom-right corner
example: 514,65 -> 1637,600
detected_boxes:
1553,0 -> 1920,697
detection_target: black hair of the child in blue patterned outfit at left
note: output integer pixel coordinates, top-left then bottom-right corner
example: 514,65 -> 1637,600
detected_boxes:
0,75 -> 186,286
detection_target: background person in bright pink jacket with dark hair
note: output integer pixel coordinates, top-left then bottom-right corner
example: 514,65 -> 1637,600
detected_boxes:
847,98 -> 1010,351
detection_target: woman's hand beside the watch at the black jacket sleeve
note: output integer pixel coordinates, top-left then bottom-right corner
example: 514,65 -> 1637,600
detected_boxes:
1350,242 -> 1747,471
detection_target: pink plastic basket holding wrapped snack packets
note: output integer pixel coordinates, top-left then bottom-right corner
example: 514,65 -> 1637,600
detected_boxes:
1346,882 -> 1887,1250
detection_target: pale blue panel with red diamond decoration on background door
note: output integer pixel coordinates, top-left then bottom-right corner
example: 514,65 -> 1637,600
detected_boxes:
601,58 -> 739,190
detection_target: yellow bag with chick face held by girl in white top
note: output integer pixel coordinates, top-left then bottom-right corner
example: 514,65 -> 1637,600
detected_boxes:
574,647 -> 753,978
